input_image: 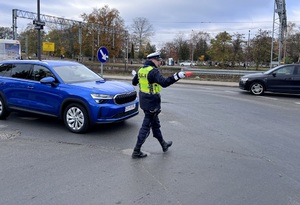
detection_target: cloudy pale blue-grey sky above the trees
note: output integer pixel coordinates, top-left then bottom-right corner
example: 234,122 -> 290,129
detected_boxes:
0,0 -> 300,47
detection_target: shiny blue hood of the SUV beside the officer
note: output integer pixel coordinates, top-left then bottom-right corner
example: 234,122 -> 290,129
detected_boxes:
73,80 -> 135,94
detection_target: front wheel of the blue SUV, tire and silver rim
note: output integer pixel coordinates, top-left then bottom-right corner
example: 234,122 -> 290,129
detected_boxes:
63,103 -> 89,133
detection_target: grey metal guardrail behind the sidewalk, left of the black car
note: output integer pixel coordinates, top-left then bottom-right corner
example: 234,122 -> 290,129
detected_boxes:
181,67 -> 263,76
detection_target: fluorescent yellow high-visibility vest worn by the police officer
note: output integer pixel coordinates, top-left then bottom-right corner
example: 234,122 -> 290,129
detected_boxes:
138,66 -> 161,94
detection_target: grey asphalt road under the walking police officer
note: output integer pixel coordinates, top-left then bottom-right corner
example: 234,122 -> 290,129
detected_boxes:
0,84 -> 300,205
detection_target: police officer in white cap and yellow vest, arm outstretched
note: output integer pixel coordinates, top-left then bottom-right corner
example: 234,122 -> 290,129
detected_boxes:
132,52 -> 185,158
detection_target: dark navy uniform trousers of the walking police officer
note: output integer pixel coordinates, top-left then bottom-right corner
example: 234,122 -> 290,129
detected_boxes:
135,110 -> 164,151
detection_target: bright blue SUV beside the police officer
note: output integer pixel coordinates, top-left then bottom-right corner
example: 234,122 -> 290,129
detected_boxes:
0,60 -> 139,133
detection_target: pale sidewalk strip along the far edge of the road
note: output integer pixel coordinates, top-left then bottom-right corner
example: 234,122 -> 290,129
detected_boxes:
103,75 -> 239,87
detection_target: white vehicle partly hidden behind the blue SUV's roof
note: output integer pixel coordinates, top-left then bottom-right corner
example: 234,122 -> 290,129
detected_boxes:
0,39 -> 21,61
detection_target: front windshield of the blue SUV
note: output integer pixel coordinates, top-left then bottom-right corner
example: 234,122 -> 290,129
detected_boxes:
53,65 -> 103,83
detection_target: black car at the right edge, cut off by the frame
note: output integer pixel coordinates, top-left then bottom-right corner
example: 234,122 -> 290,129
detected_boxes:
239,64 -> 300,95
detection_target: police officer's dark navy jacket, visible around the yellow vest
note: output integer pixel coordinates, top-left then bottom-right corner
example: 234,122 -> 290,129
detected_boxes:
132,60 -> 176,111
